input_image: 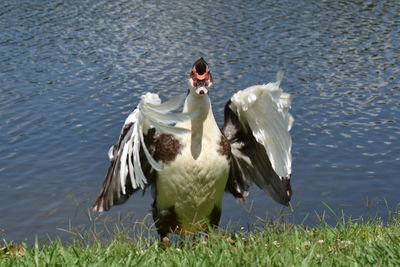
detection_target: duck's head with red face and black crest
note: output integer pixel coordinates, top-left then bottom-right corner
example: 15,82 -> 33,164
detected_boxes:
189,58 -> 212,95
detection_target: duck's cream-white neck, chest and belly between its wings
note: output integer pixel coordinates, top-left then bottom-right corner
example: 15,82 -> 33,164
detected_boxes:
154,95 -> 230,236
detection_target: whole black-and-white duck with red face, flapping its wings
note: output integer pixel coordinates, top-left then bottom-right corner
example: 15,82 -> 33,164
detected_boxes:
93,58 -> 293,242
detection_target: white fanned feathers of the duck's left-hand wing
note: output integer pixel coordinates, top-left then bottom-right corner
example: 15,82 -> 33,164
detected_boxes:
117,93 -> 194,194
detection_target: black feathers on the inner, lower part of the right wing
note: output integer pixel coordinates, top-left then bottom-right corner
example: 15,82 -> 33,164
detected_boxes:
222,100 -> 292,205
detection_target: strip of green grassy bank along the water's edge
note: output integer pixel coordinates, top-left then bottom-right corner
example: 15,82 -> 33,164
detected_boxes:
0,219 -> 400,266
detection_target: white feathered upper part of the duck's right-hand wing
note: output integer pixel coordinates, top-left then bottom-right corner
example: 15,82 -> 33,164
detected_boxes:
230,72 -> 294,177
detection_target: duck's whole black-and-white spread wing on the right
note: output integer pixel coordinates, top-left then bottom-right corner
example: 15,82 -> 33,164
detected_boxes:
222,74 -> 293,205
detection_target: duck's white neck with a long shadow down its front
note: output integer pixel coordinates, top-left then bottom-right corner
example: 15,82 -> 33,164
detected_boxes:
184,91 -> 216,159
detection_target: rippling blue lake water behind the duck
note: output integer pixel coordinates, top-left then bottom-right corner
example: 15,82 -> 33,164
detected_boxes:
0,0 -> 400,242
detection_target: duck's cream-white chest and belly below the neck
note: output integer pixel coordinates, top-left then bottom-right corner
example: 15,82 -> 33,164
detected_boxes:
156,131 -> 229,226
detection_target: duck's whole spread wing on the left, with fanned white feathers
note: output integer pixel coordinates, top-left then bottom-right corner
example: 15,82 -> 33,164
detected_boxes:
93,93 -> 192,211
